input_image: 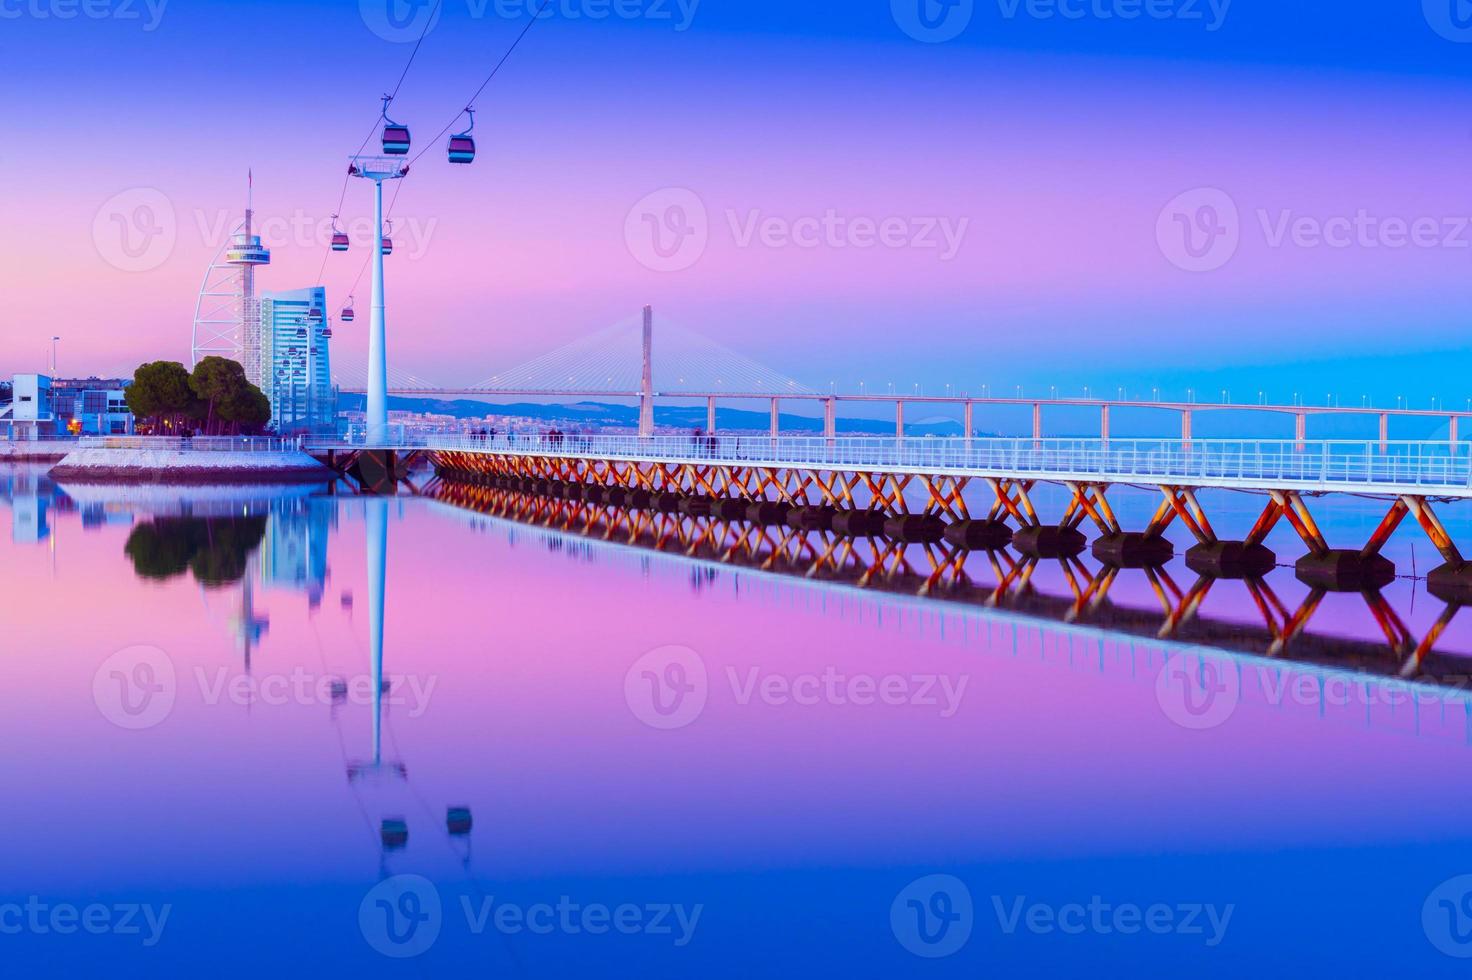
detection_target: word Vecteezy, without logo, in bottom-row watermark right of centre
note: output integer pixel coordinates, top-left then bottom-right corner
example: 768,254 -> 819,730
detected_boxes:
992,895 -> 1236,948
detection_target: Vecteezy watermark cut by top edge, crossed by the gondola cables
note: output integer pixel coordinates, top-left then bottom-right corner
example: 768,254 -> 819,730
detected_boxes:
359,0 -> 701,44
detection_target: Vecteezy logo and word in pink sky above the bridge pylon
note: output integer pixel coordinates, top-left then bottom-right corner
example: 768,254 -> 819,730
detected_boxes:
624,187 -> 972,272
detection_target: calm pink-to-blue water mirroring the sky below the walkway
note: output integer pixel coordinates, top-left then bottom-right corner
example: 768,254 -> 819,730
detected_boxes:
0,469 -> 1472,977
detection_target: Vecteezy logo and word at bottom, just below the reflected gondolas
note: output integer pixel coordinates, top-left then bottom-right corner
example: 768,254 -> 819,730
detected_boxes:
358,874 -> 705,959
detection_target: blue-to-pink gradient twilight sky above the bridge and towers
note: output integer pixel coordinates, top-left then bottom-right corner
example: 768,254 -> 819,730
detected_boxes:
0,0 -> 1472,408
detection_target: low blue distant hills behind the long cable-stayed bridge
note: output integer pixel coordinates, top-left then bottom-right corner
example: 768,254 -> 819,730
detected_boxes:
339,394 -> 964,436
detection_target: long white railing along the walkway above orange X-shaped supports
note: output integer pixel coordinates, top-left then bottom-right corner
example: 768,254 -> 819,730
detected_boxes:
309,434 -> 1472,496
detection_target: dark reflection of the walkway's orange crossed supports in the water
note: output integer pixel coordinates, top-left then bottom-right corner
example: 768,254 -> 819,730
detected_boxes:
430,481 -> 1468,684
